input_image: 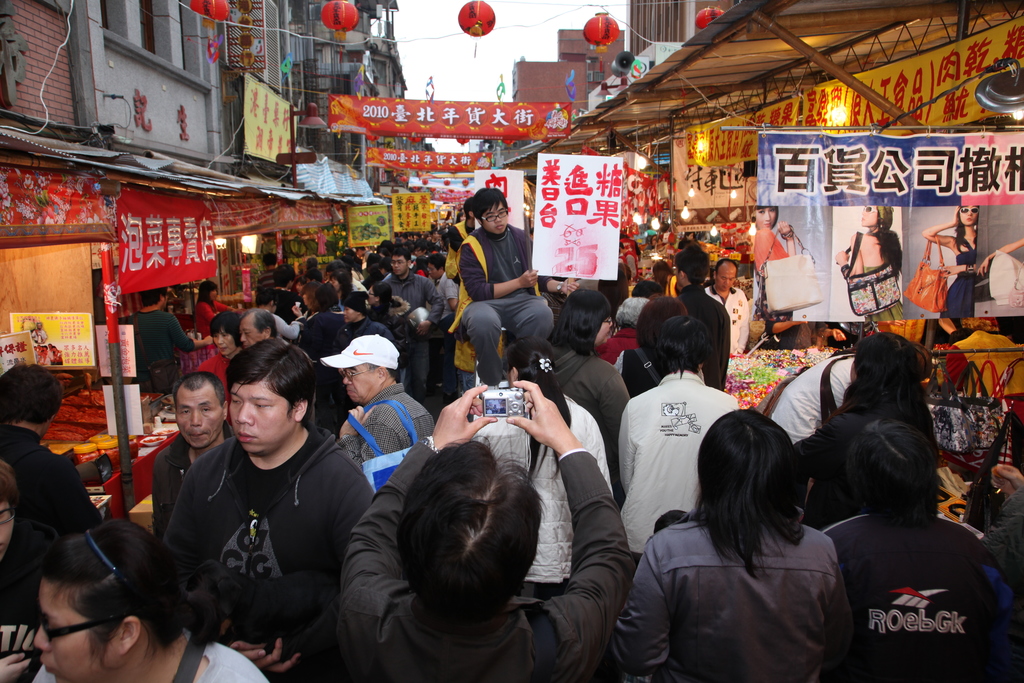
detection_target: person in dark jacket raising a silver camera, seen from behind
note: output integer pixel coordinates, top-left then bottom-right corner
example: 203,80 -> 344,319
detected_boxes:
338,382 -> 634,683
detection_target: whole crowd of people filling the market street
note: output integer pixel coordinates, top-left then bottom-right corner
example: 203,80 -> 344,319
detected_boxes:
0,190 -> 1024,683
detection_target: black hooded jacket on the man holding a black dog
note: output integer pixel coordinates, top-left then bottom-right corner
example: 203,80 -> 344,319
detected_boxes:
164,425 -> 373,682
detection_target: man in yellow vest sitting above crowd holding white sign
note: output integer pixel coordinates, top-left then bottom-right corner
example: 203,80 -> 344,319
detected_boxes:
451,187 -> 578,386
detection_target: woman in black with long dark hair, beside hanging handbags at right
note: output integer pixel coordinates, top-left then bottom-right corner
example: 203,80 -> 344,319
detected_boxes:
795,332 -> 938,528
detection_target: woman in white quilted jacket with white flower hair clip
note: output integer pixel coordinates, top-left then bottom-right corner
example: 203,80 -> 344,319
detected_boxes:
473,337 -> 611,600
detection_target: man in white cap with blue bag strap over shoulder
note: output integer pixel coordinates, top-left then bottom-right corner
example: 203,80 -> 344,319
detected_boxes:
321,335 -> 434,464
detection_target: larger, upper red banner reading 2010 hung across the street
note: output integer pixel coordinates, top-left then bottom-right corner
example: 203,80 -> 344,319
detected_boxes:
328,95 -> 572,140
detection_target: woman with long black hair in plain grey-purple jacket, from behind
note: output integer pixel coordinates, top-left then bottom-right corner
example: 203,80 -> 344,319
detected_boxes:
610,411 -> 853,681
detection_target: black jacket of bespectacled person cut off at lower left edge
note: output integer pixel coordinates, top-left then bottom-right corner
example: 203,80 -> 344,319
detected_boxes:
0,518 -> 57,681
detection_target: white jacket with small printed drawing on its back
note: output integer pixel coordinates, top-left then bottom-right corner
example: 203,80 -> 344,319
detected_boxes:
618,373 -> 739,553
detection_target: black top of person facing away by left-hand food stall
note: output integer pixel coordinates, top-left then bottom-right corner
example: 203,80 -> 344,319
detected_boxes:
0,425 -> 102,536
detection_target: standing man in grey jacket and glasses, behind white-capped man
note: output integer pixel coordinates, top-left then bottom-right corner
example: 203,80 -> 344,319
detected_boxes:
376,247 -> 444,401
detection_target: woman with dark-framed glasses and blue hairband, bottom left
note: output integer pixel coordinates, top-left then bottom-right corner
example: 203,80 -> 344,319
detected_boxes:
35,520 -> 266,683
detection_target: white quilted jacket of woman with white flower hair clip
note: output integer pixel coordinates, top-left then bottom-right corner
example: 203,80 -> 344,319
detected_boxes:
474,396 -> 611,584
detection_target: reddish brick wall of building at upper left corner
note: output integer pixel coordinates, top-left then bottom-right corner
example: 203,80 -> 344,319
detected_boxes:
13,0 -> 74,124
